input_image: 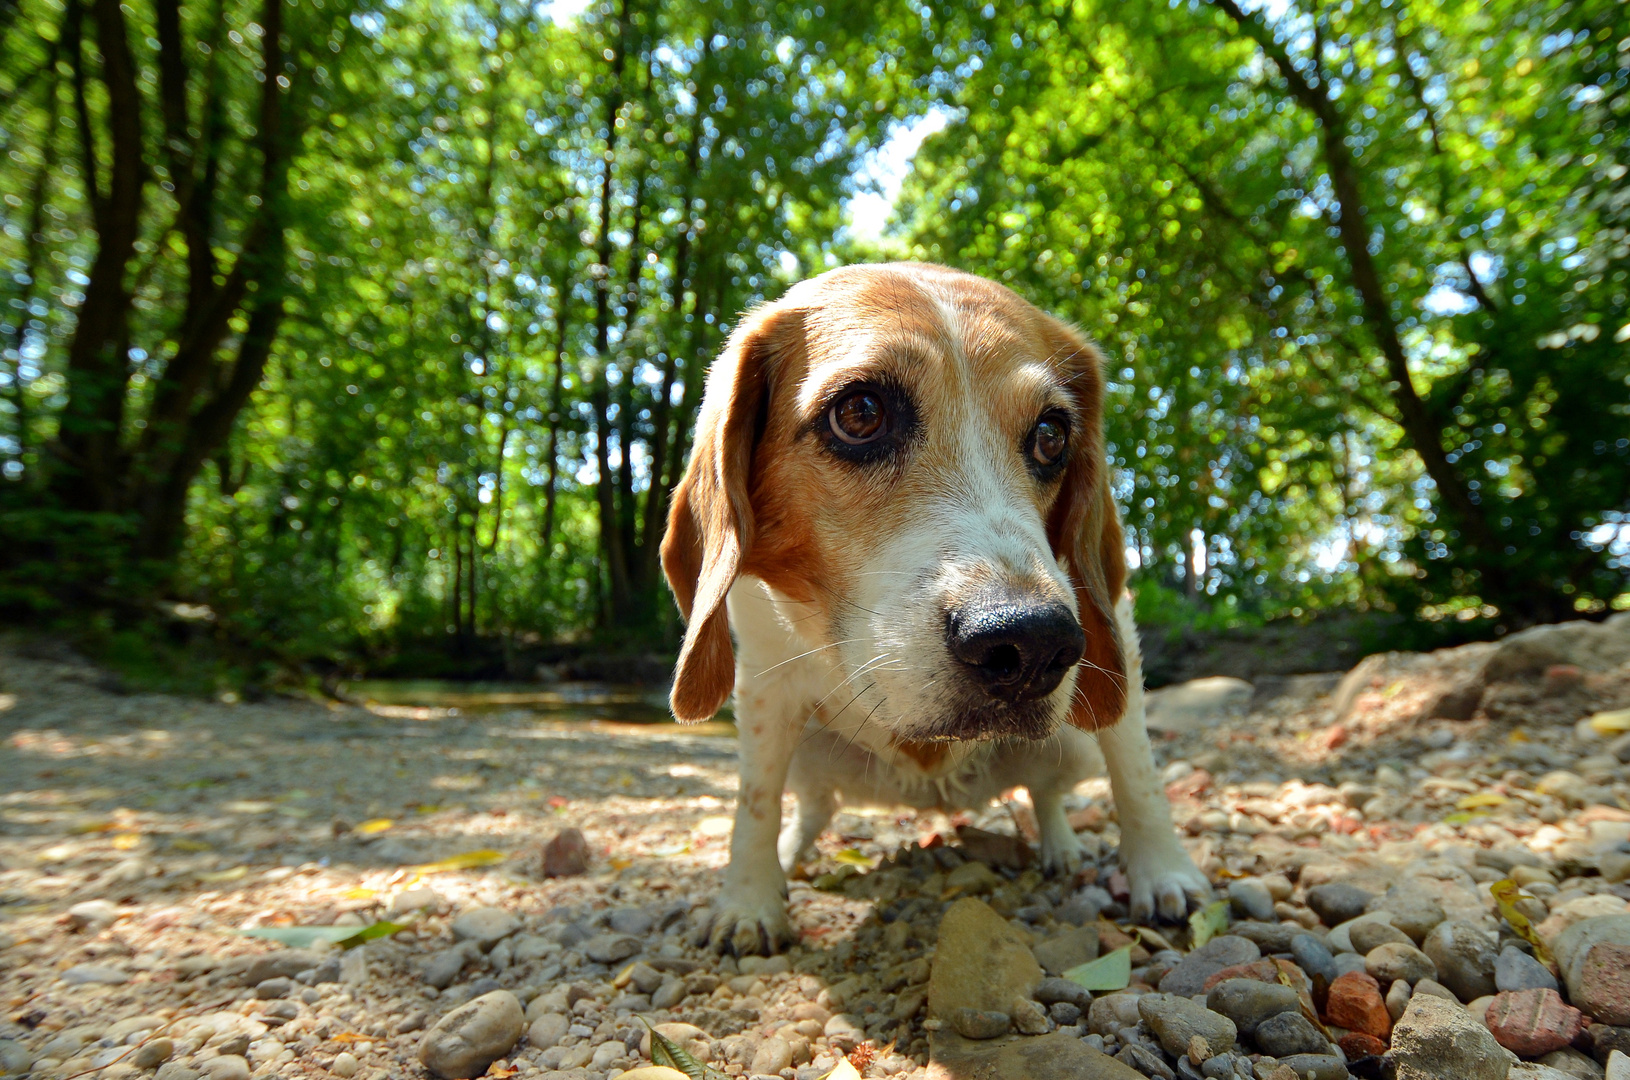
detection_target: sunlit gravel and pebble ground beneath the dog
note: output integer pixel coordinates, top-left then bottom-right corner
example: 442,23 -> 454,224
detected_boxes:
0,616 -> 1630,1080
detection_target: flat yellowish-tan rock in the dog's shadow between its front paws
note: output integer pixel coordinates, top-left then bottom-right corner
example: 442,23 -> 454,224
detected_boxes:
927,896 -> 1042,1020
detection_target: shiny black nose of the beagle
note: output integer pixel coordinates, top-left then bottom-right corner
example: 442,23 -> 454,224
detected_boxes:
945,596 -> 1087,704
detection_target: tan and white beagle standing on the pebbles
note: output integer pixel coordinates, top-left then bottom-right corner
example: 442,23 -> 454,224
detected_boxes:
662,262 -> 1209,955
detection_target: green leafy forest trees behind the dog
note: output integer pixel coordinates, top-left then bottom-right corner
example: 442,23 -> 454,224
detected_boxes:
0,0 -> 1630,677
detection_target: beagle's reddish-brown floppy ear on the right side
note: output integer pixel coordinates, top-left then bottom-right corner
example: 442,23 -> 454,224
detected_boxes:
1046,319 -> 1126,731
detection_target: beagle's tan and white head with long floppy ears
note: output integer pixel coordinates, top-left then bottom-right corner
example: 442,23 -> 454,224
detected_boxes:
662,264 -> 1126,743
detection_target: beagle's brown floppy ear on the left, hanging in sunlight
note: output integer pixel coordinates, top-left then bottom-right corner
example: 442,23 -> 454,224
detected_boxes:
662,306 -> 802,723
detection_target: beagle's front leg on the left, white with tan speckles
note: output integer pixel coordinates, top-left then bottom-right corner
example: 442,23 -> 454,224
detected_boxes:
707,693 -> 800,956
